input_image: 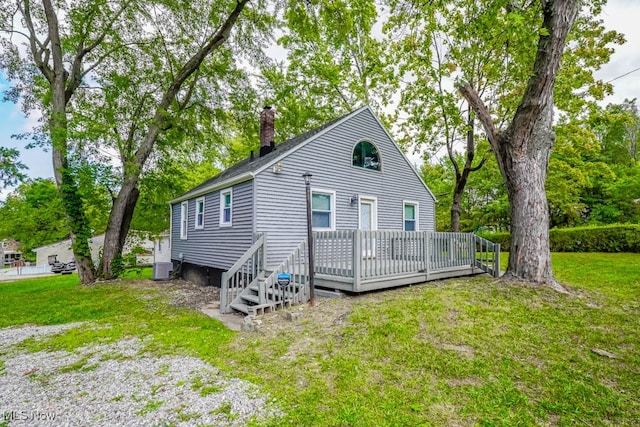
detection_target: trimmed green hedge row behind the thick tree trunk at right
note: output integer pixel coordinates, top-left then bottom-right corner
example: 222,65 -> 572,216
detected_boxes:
478,224 -> 640,253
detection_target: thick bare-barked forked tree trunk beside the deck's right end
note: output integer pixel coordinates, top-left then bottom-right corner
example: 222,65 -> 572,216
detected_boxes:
458,0 -> 581,290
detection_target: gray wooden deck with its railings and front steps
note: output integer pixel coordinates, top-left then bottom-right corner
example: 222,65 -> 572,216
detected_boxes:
220,230 -> 500,314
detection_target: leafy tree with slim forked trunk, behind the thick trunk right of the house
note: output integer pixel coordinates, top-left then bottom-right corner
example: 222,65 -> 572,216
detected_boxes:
387,0 -> 622,231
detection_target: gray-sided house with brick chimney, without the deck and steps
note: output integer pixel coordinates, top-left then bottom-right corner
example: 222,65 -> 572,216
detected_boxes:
171,107 -> 435,285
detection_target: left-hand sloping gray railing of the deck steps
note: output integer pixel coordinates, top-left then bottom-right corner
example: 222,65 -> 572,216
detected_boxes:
220,234 -> 267,313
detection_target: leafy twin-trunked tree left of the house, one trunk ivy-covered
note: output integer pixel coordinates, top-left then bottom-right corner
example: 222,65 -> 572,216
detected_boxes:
0,0 -> 262,283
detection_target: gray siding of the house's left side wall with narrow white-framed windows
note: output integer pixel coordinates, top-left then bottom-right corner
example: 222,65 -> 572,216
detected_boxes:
171,181 -> 254,270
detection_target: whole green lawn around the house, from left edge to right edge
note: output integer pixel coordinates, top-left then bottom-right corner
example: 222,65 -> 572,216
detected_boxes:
0,253 -> 640,426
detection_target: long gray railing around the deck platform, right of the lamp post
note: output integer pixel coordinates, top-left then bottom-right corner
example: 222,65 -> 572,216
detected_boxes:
314,230 -> 500,281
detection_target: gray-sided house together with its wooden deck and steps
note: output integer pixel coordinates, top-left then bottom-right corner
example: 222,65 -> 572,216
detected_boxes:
170,107 -> 500,314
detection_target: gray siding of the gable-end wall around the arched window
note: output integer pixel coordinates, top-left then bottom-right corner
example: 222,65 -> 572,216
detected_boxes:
255,109 -> 435,265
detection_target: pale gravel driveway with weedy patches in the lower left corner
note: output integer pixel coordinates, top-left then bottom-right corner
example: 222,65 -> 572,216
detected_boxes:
0,323 -> 280,426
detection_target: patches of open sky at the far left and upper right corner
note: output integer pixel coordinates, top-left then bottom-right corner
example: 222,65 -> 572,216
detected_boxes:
0,0 -> 640,200
